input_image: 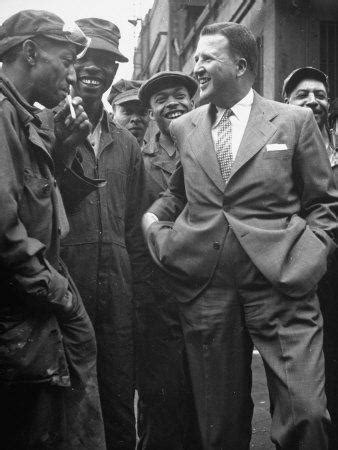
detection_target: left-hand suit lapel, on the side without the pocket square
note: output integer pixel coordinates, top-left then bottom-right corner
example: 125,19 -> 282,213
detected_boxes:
188,105 -> 225,192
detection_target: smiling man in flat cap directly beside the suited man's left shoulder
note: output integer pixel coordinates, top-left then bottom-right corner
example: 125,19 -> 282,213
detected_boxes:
135,71 -> 200,450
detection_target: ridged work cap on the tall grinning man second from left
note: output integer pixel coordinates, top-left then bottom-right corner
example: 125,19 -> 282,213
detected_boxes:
76,17 -> 128,62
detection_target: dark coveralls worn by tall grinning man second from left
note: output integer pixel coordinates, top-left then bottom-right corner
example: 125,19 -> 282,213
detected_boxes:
61,111 -> 144,450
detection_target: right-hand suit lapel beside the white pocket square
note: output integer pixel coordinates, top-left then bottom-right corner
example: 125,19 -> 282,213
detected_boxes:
229,93 -> 278,180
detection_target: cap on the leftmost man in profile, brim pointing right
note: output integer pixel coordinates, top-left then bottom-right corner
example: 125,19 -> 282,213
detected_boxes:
0,9 -> 89,59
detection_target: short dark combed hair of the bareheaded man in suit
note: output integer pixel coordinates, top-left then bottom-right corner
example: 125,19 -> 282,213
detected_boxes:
201,22 -> 258,75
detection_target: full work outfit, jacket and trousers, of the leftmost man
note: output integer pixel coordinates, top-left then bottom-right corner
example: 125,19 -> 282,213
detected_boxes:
0,76 -> 106,450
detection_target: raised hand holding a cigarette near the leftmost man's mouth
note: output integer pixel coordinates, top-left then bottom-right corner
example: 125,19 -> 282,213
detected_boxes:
54,97 -> 92,149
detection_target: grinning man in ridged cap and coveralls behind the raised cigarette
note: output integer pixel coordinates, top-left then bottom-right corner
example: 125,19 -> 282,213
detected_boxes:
61,18 -> 145,450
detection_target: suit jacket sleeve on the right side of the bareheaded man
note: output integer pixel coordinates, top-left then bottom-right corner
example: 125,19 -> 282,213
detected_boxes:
294,110 -> 338,252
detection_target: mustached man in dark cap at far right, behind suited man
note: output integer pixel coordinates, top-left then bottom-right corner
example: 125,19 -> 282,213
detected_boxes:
282,67 -> 338,449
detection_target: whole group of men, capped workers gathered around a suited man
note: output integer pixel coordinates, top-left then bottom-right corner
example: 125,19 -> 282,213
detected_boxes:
0,10 -> 338,450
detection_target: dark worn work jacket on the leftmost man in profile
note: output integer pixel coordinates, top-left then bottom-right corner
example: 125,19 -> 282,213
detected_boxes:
0,76 -> 70,386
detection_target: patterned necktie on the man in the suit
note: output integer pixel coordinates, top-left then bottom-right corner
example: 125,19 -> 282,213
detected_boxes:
215,109 -> 233,182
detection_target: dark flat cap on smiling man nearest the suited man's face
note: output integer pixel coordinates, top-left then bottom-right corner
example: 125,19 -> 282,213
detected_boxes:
138,71 -> 198,106
